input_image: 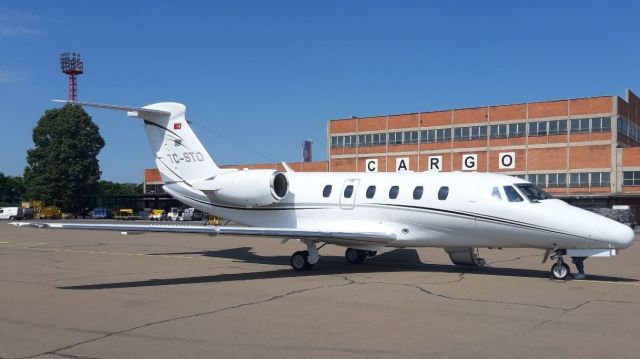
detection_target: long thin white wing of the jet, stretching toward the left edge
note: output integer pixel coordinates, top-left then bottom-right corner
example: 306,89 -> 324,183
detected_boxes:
10,222 -> 396,248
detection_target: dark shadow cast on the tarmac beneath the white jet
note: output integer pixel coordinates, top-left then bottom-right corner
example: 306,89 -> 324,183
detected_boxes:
58,247 -> 638,290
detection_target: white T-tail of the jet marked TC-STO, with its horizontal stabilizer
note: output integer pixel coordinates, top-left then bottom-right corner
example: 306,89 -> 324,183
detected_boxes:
56,101 -> 220,184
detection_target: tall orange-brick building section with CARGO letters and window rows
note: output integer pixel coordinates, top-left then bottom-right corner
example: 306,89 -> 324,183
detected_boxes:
328,91 -> 640,203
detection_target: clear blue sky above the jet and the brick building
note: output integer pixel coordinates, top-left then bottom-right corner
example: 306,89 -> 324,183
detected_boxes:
0,0 -> 640,182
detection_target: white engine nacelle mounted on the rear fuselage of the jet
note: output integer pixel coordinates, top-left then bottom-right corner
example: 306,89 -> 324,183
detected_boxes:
210,170 -> 289,207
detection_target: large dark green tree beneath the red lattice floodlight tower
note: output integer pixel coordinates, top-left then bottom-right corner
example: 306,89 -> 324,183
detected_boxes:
24,104 -> 104,213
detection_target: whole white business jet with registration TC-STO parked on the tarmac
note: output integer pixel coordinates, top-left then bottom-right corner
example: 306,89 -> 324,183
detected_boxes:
10,101 -> 634,280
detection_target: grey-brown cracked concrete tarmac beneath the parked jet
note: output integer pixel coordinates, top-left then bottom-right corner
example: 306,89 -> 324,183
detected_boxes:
0,222 -> 640,359
